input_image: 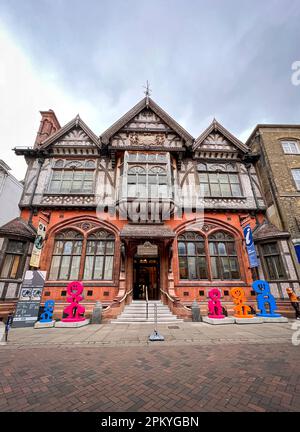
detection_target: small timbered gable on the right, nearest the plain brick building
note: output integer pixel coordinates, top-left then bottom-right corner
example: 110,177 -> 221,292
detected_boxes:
193,119 -> 248,159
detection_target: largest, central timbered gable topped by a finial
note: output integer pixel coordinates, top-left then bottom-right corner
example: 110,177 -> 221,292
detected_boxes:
100,97 -> 193,151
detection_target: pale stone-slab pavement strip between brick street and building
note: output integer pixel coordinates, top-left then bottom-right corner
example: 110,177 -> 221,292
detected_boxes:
2,320 -> 294,347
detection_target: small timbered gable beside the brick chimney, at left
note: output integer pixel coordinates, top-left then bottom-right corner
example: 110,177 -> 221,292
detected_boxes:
41,116 -> 100,155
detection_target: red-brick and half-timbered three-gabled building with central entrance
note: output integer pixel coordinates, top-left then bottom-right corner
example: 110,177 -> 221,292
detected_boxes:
0,96 -> 299,319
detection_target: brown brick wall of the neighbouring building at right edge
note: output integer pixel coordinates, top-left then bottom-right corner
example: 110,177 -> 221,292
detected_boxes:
249,125 -> 300,275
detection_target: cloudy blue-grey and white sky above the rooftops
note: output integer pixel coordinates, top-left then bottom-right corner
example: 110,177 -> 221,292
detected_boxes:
0,0 -> 300,180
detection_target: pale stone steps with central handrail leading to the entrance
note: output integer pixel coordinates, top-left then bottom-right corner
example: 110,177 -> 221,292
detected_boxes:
111,300 -> 183,324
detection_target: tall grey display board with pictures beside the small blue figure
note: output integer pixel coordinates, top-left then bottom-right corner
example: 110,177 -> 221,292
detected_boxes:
12,270 -> 46,327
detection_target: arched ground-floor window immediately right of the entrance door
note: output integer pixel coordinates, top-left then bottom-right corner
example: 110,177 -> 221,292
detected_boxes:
178,232 -> 208,280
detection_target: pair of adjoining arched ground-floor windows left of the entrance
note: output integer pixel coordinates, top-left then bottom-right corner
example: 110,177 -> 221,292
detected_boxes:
48,230 -> 115,280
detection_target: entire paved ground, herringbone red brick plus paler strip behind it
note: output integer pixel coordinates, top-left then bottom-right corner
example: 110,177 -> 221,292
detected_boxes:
0,323 -> 300,412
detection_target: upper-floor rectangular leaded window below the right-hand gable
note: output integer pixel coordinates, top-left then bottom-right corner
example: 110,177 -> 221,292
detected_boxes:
198,164 -> 243,197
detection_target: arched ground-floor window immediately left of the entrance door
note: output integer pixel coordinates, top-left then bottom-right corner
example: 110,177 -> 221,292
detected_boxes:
83,230 -> 115,280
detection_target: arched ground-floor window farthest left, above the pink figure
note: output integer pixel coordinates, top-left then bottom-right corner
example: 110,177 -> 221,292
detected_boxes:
49,230 -> 83,280
